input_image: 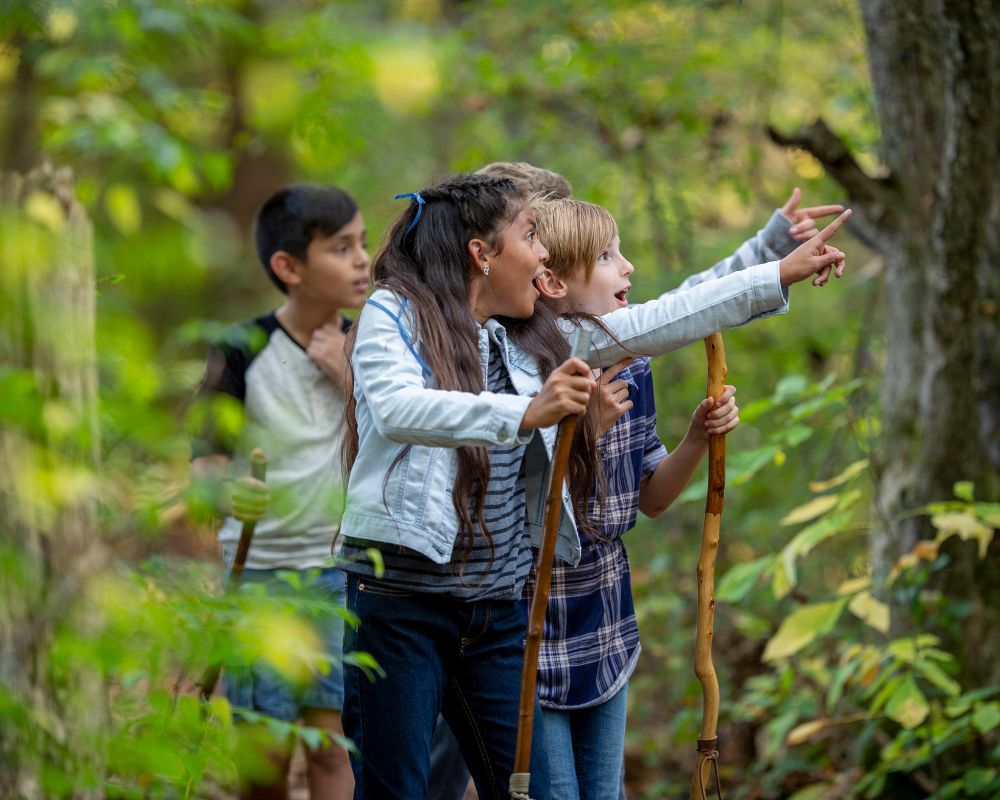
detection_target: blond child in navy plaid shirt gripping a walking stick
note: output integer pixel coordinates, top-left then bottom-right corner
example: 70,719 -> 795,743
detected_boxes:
529,199 -> 752,800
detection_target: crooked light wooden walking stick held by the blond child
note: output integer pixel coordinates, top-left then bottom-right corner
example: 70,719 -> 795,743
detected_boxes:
691,333 -> 727,800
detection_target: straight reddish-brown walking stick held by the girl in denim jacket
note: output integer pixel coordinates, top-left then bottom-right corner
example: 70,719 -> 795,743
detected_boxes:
509,328 -> 590,800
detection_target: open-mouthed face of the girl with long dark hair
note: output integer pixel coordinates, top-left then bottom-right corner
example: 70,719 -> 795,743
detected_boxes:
471,205 -> 549,324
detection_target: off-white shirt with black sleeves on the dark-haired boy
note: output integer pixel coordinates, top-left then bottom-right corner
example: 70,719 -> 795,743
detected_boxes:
193,313 -> 350,569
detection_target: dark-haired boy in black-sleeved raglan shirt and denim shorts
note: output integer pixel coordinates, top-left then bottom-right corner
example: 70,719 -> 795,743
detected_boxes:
191,185 -> 369,800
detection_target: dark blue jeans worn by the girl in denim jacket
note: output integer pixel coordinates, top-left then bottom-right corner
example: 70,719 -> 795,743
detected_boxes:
343,575 -> 549,800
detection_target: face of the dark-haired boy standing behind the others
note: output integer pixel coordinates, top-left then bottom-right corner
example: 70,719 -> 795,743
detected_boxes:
298,211 -> 371,313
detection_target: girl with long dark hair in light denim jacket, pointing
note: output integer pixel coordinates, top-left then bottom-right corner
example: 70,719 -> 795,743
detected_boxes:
341,176 -> 842,800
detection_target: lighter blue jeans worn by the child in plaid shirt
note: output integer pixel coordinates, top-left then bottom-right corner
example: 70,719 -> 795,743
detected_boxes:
542,684 -> 628,800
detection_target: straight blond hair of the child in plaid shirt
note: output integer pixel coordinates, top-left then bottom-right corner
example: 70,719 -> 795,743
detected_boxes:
531,198 -> 618,281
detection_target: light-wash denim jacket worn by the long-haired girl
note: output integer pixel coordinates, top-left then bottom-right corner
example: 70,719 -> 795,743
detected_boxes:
341,213 -> 797,564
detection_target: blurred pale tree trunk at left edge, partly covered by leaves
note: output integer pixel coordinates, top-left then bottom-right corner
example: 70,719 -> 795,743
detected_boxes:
0,168 -> 105,798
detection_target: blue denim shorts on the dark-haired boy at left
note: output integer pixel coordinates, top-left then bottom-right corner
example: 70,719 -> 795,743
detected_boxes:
225,567 -> 345,722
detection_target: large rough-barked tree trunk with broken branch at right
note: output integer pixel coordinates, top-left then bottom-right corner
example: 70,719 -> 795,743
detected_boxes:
772,0 -> 1000,683
